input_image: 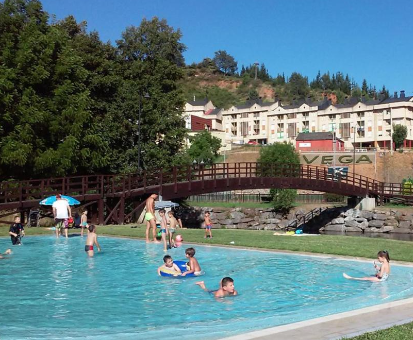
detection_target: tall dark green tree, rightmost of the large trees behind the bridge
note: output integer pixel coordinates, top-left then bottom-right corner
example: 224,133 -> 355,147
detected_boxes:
117,18 -> 186,171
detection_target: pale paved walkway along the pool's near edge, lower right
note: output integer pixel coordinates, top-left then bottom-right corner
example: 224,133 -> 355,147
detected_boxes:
225,298 -> 413,340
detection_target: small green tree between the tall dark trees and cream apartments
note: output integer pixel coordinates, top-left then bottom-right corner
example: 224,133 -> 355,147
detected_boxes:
187,130 -> 221,165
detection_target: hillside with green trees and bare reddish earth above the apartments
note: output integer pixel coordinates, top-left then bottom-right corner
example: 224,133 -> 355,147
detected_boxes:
181,56 -> 389,108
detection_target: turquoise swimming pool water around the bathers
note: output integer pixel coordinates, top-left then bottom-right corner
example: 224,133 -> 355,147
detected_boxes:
0,236 -> 413,340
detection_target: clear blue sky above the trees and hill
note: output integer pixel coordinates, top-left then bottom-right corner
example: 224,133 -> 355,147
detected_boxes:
42,0 -> 413,95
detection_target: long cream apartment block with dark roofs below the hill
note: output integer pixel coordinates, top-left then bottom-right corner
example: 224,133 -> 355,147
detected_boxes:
220,91 -> 413,149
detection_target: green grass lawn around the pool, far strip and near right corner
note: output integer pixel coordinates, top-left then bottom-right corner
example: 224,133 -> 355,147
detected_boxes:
0,225 -> 413,340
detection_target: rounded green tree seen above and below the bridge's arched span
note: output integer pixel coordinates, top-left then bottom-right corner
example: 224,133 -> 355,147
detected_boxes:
258,143 -> 300,212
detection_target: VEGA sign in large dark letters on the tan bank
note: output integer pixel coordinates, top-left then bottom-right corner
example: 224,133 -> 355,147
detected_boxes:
300,152 -> 376,165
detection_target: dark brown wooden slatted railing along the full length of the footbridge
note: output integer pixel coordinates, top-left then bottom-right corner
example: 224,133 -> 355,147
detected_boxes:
0,162 -> 413,204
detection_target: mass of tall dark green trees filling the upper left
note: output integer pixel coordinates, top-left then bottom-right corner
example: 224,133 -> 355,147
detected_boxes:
0,0 -> 186,178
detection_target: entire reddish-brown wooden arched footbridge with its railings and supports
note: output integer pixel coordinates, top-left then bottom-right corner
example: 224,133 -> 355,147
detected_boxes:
0,163 -> 413,224
